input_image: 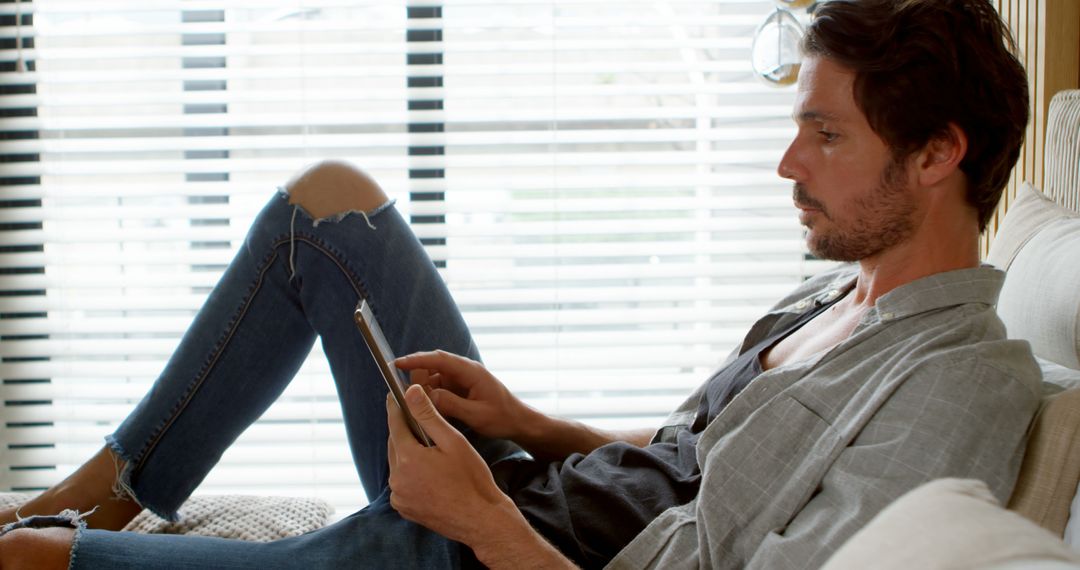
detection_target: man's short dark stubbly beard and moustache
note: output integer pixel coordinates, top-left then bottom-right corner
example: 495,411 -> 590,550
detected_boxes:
793,159 -> 916,261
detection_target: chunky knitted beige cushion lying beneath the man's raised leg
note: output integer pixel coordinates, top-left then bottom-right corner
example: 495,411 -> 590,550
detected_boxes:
0,493 -> 334,542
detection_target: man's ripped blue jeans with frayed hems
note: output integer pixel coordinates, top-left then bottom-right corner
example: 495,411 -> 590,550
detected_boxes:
72,190 -> 515,570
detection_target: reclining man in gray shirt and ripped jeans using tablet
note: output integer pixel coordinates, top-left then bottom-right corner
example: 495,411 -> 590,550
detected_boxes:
0,0 -> 1039,569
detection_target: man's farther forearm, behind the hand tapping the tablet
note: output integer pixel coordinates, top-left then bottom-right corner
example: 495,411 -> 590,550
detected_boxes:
514,408 -> 656,459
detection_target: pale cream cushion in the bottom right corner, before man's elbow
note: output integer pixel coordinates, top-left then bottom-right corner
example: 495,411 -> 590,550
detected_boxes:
822,479 -> 1080,570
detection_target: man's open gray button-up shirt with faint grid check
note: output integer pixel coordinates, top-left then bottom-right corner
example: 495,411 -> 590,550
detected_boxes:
610,266 -> 1040,570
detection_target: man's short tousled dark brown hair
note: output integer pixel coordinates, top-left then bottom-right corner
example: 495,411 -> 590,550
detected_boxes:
802,0 -> 1028,231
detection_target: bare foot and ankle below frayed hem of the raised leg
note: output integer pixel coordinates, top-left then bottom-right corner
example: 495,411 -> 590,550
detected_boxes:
0,448 -> 143,528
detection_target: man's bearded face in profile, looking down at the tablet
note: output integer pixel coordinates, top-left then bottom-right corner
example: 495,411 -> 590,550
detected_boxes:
778,57 -> 916,261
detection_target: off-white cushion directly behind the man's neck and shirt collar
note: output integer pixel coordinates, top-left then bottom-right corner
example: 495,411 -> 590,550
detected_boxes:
987,184 -> 1080,368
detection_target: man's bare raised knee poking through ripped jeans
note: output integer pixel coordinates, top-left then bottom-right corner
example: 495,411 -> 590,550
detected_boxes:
285,160 -> 389,219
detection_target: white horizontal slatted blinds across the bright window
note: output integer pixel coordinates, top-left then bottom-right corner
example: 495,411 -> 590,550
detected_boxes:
0,0 -> 820,515
